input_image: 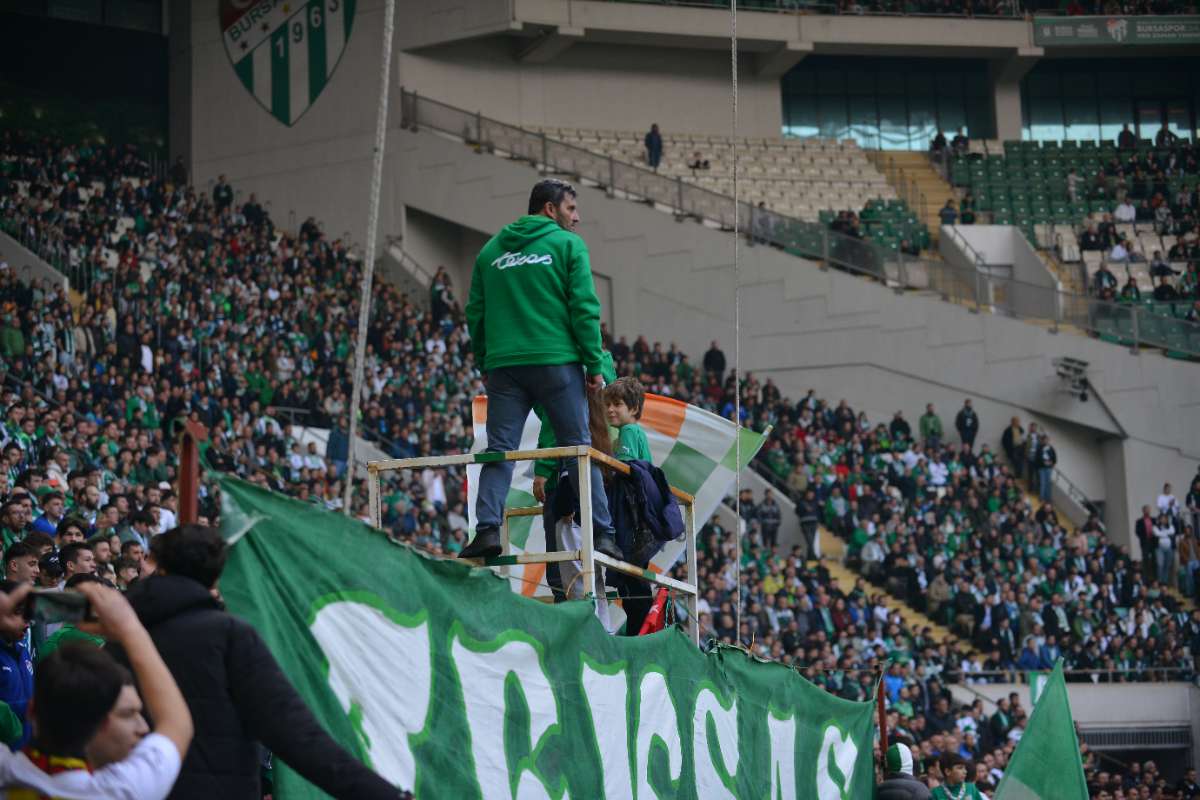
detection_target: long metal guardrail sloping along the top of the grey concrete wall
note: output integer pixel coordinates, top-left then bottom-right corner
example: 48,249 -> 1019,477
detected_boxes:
401,89 -> 1200,357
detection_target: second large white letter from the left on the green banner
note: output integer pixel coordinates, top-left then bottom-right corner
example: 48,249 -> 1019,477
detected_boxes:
450,634 -> 565,800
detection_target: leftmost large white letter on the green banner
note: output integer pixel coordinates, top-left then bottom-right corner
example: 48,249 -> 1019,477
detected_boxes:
310,600 -> 433,786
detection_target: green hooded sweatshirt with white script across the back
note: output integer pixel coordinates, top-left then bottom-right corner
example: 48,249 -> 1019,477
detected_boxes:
467,215 -> 600,375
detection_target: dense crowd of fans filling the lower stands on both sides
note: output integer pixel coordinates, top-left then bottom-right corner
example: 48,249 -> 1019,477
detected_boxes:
0,134 -> 1200,796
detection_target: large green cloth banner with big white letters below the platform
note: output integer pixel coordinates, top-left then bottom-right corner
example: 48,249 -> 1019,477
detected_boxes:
221,479 -> 875,800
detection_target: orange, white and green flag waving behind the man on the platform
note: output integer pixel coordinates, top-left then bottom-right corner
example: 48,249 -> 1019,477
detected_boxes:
467,395 -> 767,596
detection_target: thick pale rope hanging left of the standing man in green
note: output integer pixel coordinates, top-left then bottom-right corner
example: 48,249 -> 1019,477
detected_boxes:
342,0 -> 396,517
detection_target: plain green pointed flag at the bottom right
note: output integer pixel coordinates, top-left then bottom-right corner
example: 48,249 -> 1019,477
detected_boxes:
996,658 -> 1087,800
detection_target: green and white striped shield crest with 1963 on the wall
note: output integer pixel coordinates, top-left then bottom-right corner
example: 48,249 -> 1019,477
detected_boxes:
221,0 -> 356,126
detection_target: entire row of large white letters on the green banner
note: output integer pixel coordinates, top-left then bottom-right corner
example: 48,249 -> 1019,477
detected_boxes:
310,609 -> 873,800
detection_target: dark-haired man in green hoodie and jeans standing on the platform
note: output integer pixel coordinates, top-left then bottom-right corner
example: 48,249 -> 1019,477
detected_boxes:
458,179 -> 620,558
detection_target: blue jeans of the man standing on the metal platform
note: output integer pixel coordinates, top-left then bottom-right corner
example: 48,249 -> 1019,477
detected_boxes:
475,363 -> 612,534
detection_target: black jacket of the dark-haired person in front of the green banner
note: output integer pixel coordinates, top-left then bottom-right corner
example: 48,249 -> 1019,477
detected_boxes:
127,576 -> 401,800
